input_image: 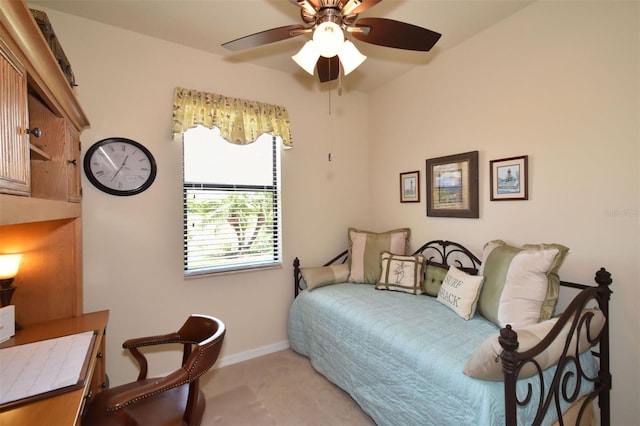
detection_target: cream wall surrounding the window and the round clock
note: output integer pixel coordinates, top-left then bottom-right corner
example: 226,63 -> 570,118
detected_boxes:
41,10 -> 369,385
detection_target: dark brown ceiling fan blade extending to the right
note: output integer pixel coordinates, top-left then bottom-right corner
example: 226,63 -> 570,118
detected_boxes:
351,18 -> 442,52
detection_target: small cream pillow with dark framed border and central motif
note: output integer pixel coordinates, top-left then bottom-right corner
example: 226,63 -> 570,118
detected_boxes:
376,251 -> 427,294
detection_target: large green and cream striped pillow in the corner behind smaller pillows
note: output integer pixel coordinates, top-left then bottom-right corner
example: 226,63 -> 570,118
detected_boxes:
348,228 -> 411,284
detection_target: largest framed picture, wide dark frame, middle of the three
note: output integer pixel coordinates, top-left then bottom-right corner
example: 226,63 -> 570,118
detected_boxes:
427,151 -> 480,219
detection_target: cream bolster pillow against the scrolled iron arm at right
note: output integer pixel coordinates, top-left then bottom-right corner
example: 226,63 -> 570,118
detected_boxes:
463,309 -> 606,381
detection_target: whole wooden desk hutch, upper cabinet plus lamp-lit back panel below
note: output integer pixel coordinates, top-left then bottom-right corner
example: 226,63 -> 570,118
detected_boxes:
0,0 -> 89,326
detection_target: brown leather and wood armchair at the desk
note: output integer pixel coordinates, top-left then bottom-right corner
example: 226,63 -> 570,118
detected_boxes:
82,315 -> 225,426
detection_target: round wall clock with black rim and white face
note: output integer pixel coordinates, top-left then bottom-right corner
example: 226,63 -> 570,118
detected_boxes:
84,138 -> 157,196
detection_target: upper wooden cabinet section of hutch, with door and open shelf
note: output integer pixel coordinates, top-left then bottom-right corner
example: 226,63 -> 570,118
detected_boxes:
0,0 -> 89,211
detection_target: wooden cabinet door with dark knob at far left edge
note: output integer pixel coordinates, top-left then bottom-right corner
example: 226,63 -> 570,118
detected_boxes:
0,40 -> 31,195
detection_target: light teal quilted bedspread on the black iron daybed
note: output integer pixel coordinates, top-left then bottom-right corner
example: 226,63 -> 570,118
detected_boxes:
288,283 -> 596,426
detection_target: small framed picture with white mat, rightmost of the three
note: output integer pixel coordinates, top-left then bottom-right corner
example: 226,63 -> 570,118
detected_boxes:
489,155 -> 529,201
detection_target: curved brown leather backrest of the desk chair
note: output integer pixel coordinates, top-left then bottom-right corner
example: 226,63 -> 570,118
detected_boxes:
178,314 -> 226,380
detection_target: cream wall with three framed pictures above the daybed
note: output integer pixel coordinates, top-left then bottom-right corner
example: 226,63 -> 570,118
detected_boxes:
369,1 -> 640,425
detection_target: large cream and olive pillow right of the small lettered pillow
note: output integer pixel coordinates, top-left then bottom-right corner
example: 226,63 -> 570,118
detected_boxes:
478,240 -> 569,328
